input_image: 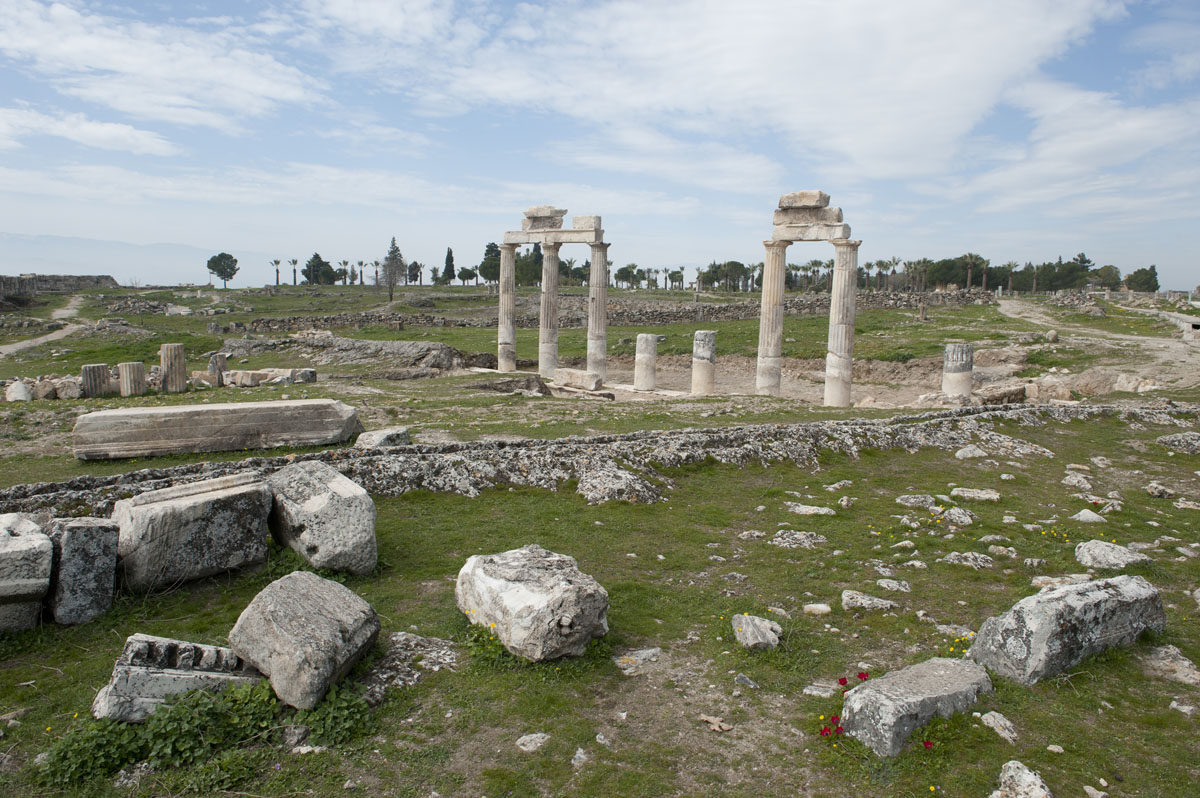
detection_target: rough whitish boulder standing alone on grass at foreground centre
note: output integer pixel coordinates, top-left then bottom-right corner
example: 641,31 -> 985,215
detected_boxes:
455,545 -> 608,662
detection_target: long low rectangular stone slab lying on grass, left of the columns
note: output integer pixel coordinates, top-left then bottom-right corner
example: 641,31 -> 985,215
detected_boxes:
73,396 -> 362,460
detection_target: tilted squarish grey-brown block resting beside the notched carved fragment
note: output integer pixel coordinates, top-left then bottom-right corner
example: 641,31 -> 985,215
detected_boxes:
229,571 -> 379,709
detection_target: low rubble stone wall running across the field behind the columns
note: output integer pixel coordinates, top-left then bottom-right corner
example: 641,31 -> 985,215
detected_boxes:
236,290 -> 996,332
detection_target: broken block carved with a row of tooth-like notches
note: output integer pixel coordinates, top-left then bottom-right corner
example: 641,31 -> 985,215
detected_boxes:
91,635 -> 263,724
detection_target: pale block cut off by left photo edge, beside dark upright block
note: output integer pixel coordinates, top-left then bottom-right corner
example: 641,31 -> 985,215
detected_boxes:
0,512 -> 54,630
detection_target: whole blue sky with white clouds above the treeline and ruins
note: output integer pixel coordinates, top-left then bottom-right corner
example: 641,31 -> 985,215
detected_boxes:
0,0 -> 1200,289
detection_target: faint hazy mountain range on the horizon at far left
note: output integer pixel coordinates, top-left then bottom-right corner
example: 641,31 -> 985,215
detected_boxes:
0,233 -> 275,286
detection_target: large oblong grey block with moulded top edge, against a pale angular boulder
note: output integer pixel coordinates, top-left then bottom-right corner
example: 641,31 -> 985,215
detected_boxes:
112,473 -> 271,593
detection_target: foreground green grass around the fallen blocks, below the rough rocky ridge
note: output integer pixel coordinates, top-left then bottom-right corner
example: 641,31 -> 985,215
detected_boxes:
0,408 -> 1200,798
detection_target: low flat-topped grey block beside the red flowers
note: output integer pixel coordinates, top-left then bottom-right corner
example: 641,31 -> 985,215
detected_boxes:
841,658 -> 992,756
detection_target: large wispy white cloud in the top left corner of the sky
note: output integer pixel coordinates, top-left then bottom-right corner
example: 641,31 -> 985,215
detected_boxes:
0,0 -> 320,132
